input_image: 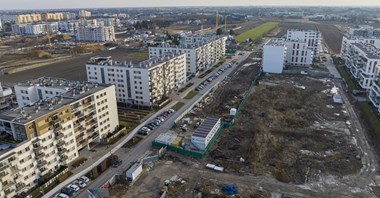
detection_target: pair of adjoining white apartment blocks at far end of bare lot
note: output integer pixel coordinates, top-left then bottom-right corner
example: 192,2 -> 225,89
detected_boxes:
263,30 -> 321,73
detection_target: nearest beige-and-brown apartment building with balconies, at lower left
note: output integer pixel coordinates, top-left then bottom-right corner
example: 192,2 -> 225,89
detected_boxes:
0,77 -> 118,197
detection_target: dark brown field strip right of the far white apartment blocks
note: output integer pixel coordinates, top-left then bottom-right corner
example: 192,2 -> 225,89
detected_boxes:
317,24 -> 343,54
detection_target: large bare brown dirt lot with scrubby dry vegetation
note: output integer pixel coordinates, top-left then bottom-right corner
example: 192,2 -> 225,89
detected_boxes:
209,76 -> 362,184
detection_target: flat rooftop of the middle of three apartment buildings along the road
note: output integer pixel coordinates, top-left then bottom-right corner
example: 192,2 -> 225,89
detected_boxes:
87,53 -> 184,69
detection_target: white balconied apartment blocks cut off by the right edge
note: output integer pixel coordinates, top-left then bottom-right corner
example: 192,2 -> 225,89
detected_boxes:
340,26 -> 380,113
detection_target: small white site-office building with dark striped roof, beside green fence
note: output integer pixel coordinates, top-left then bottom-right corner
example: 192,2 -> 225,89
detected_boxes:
191,116 -> 221,151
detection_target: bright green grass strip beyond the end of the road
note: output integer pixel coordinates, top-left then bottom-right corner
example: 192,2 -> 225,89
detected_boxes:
235,22 -> 278,43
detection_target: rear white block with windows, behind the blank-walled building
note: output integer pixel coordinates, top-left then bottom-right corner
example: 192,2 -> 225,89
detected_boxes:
286,30 -> 321,56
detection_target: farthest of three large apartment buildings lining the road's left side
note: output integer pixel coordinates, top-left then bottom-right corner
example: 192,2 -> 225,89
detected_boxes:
149,36 -> 227,76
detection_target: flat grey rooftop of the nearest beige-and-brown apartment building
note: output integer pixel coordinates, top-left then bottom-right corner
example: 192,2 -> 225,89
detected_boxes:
0,77 -> 112,124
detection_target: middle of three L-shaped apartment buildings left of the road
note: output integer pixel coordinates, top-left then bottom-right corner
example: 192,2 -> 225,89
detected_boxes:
86,53 -> 186,106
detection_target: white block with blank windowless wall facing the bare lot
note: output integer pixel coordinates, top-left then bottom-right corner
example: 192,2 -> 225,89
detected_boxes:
262,39 -> 286,74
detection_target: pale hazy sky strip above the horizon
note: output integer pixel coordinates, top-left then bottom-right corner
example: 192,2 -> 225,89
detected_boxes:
0,0 -> 380,9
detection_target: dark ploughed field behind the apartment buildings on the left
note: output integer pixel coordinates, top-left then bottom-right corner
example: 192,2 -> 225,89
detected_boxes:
1,49 -> 147,85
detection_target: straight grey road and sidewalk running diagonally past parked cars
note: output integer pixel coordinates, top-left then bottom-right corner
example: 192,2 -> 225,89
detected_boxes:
44,52 -> 250,198
